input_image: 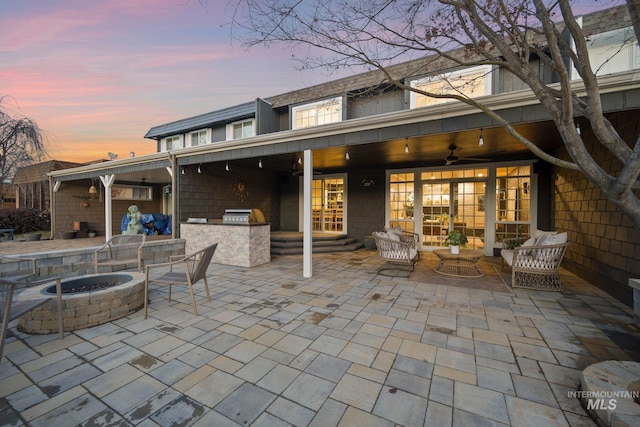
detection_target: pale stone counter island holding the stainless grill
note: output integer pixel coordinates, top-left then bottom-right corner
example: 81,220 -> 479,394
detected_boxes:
180,219 -> 271,267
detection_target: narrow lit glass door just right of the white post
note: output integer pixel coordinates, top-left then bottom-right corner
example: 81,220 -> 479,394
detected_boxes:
311,177 -> 346,233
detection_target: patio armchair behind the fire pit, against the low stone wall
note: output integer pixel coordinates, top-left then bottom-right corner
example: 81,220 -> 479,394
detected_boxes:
93,234 -> 145,274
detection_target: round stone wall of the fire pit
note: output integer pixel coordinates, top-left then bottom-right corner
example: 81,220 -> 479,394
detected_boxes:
18,272 -> 144,334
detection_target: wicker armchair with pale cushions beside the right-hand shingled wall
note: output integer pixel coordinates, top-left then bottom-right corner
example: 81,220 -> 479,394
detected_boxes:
500,231 -> 569,291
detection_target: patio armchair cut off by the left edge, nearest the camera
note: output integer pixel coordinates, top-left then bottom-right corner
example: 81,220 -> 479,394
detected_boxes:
0,256 -> 64,360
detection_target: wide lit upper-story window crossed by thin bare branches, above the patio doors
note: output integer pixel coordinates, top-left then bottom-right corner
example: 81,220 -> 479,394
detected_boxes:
410,65 -> 491,108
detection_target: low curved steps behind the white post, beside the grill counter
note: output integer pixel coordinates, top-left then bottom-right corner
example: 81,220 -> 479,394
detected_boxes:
271,231 -> 364,255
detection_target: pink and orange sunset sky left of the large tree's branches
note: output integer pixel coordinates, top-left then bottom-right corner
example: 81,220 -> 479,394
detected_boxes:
0,0 -> 350,162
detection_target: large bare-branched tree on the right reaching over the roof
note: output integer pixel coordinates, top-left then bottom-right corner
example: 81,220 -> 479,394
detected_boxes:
234,0 -> 640,230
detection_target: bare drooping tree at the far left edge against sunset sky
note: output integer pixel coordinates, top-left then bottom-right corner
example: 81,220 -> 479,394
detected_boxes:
0,97 -> 47,203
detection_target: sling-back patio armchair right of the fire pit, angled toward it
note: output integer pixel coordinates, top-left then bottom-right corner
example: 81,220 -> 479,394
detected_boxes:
144,243 -> 218,319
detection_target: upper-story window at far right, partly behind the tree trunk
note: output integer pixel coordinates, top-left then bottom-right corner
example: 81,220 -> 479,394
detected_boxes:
573,27 -> 640,79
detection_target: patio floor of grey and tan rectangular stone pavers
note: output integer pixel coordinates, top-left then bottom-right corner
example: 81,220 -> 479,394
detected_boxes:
0,246 -> 640,426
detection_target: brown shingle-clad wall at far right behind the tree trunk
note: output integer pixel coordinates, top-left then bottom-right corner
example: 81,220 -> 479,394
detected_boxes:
552,111 -> 640,304
